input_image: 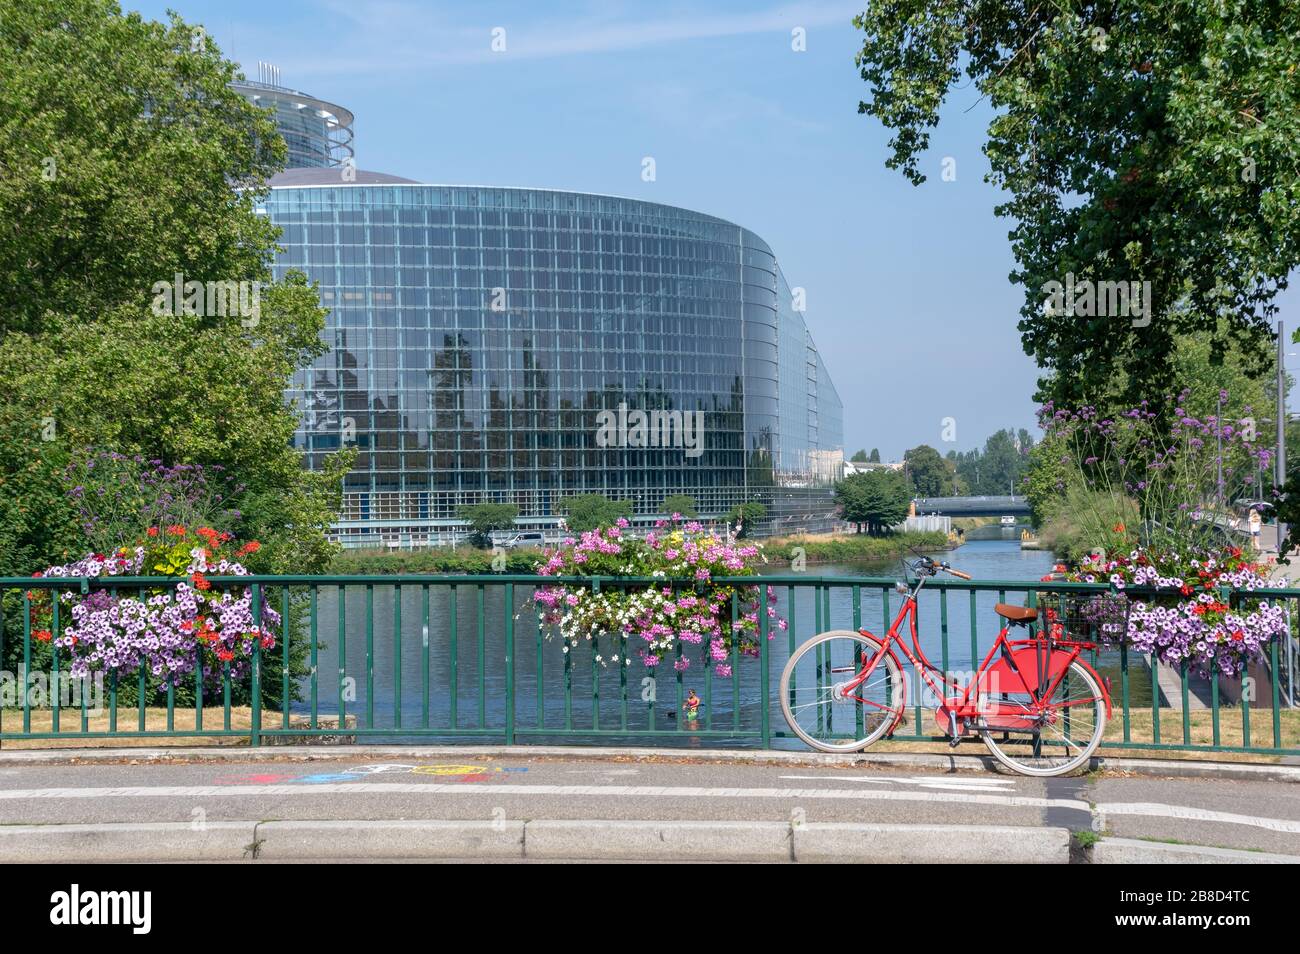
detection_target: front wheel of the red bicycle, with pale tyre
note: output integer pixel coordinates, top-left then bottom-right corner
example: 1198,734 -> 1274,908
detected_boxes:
780,629 -> 905,753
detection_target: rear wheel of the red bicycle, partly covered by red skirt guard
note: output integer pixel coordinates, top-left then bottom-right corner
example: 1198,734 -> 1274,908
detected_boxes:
980,662 -> 1106,776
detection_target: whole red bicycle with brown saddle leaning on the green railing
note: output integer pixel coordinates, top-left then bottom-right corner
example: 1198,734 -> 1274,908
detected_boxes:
780,556 -> 1110,776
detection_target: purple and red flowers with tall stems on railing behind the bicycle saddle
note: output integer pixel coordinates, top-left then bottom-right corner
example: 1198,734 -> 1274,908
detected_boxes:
1041,391 -> 1287,676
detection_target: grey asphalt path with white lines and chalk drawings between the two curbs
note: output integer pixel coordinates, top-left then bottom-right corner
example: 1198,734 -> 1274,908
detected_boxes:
0,754 -> 1300,855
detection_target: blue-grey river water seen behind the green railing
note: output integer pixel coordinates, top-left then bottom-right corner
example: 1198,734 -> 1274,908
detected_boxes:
293,530 -> 1052,745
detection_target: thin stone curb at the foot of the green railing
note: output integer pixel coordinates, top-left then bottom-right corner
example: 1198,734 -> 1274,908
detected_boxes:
0,745 -> 1300,782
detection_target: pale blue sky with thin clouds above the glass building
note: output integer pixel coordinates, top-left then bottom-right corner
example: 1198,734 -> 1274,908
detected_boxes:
124,0 -> 1300,459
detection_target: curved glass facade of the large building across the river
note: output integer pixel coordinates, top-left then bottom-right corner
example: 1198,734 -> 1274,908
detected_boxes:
265,179 -> 842,543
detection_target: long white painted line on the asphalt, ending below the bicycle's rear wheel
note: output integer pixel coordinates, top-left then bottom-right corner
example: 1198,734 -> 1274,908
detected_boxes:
0,781 -> 1089,811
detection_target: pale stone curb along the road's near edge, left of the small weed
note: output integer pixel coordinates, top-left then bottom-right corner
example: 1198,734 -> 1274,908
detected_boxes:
0,820 -> 1076,864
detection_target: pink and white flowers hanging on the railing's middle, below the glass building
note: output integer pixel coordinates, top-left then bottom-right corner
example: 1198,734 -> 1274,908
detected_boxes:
533,513 -> 787,677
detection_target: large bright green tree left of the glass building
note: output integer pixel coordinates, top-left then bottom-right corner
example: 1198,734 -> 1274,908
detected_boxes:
0,0 -> 352,572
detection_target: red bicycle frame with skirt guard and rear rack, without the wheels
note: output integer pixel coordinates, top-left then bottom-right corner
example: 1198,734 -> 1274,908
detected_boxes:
842,576 -> 1110,736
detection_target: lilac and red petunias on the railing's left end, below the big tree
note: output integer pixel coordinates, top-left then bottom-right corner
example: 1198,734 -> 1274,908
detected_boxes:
29,524 -> 281,686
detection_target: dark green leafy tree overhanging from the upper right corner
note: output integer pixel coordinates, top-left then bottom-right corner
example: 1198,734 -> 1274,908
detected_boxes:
854,0 -> 1300,407
